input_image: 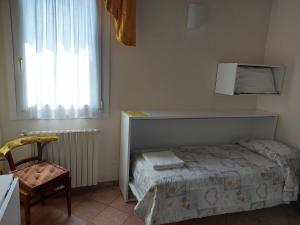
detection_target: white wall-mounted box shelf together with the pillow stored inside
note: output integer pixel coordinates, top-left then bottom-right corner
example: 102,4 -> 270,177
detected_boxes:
215,63 -> 285,95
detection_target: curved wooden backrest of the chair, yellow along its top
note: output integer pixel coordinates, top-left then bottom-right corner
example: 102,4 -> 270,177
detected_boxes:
0,136 -> 58,171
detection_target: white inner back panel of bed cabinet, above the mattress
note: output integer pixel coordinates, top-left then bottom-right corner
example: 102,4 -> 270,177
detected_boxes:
130,117 -> 276,149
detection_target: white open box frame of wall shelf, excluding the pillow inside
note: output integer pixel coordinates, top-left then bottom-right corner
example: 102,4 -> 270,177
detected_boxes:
215,63 -> 285,95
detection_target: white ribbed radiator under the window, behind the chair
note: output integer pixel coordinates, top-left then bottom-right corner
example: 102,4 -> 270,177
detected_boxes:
26,129 -> 99,187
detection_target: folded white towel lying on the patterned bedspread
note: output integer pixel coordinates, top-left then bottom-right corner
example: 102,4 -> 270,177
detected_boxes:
142,151 -> 184,170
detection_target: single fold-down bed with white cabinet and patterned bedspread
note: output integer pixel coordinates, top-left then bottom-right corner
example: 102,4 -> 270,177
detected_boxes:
119,110 -> 300,225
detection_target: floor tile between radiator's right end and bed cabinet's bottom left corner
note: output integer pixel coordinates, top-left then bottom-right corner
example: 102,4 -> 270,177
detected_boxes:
90,187 -> 121,204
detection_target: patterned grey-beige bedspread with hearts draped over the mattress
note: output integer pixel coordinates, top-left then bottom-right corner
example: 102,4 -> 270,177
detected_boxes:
131,145 -> 298,225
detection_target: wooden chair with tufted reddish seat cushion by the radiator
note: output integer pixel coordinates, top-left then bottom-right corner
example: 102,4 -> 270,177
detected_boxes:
0,136 -> 71,225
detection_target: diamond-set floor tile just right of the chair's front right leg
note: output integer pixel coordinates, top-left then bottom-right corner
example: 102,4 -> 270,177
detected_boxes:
72,199 -> 106,222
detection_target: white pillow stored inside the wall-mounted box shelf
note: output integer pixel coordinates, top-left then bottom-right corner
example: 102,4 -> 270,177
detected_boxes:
235,66 -> 276,94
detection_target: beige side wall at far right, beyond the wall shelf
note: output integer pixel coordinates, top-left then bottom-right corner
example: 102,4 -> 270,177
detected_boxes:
257,0 -> 300,149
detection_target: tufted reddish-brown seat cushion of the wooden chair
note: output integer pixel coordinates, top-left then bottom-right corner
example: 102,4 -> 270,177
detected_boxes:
11,161 -> 69,192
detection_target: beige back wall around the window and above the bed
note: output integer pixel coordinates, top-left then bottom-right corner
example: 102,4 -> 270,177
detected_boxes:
0,0 -> 271,181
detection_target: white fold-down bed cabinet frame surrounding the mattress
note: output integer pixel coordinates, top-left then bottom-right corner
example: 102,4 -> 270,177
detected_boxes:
119,110 -> 278,201
